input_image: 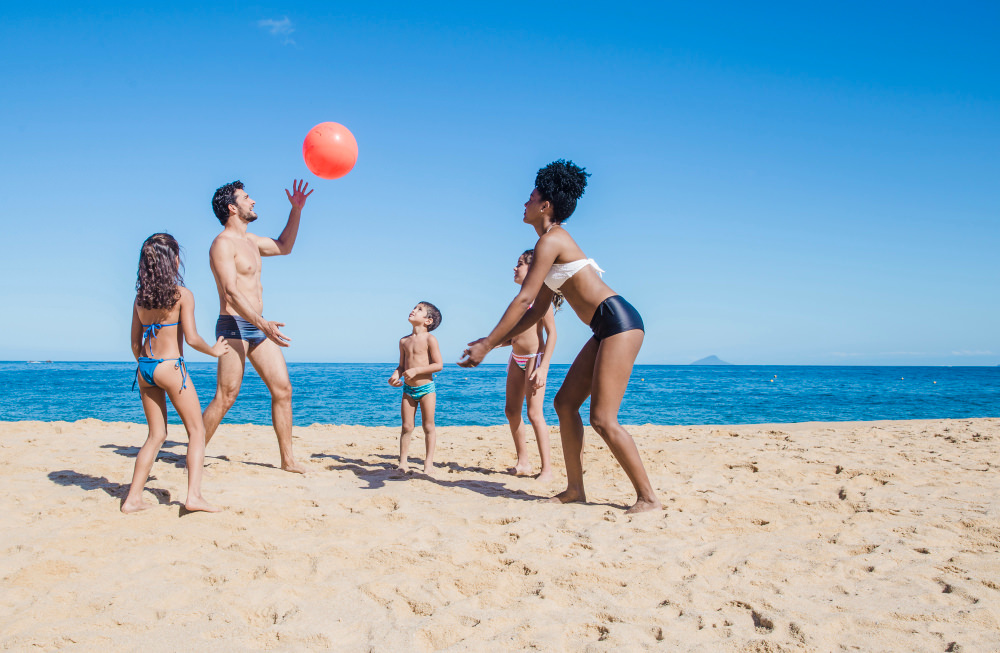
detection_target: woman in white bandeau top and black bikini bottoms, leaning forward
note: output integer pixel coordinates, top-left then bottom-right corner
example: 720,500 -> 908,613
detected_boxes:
459,159 -> 662,513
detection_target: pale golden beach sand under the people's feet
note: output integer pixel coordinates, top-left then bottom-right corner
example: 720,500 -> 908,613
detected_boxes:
0,419 -> 1000,652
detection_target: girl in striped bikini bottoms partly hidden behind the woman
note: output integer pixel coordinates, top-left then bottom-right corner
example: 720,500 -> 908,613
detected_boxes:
504,249 -> 562,482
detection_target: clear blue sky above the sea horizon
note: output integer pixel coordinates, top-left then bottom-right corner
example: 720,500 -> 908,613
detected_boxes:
0,2 -> 1000,365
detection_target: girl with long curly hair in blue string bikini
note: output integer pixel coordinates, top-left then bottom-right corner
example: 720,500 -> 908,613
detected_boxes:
121,233 -> 229,513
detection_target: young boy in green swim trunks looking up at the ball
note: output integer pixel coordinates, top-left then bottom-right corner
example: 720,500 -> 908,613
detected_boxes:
389,302 -> 444,476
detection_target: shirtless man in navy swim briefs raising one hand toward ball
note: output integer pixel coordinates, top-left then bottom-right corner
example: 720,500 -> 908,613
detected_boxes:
203,180 -> 312,474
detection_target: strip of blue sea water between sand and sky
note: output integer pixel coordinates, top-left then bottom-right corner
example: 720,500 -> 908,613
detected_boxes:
0,362 -> 1000,426
